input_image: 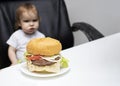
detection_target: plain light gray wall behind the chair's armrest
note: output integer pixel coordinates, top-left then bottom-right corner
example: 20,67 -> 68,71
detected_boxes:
65,0 -> 120,45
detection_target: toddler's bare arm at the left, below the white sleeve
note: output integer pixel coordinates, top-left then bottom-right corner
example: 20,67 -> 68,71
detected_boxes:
8,46 -> 17,65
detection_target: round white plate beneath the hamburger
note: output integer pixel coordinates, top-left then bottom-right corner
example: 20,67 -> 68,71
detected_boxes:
20,63 -> 70,77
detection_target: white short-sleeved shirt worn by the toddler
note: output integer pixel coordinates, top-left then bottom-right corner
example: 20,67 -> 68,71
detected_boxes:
7,30 -> 45,61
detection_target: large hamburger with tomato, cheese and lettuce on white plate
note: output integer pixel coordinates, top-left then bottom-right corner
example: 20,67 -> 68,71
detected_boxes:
25,37 -> 68,73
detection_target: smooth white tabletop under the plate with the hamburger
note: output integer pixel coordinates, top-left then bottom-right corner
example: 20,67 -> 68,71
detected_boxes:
0,33 -> 120,86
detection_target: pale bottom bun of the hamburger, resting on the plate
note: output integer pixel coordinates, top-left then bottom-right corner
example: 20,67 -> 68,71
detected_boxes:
27,61 -> 60,73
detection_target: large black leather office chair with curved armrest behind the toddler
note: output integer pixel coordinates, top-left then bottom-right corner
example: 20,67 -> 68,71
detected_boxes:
0,0 -> 104,69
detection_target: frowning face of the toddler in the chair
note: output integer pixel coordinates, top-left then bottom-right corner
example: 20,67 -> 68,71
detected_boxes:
19,12 -> 39,34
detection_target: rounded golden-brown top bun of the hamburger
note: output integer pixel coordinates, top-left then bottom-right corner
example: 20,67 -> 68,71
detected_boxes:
26,37 -> 62,56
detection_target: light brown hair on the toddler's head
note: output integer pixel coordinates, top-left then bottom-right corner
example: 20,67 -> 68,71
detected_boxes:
15,3 -> 40,29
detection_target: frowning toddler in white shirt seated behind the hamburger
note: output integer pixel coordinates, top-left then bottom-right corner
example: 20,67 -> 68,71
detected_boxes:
7,3 -> 45,65
